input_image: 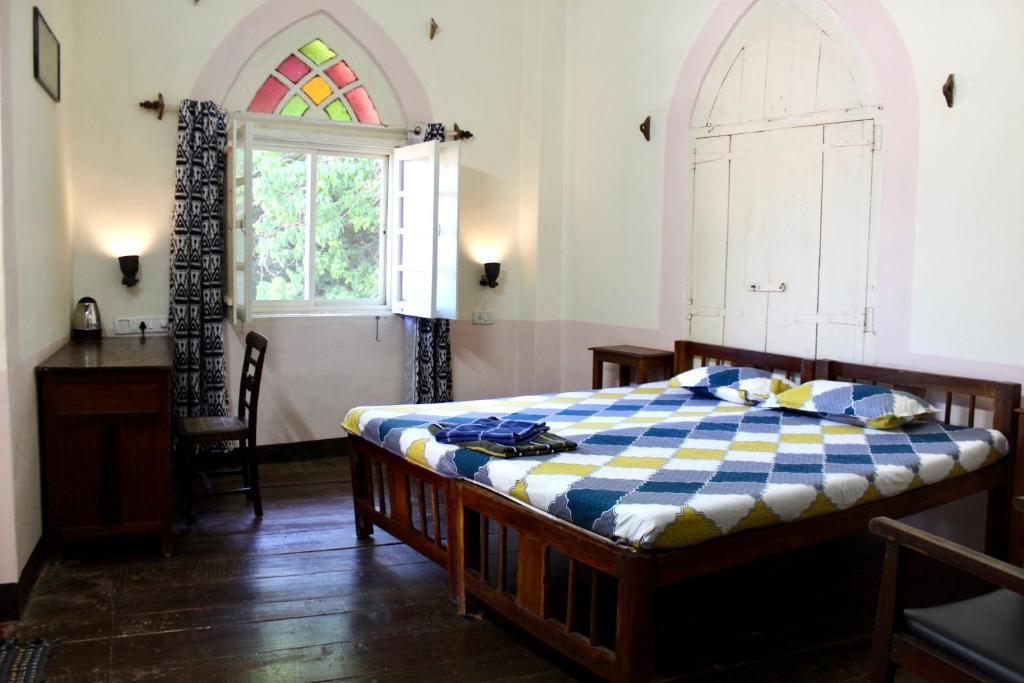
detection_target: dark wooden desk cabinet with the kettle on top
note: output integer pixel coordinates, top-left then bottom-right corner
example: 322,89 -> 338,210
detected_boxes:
36,337 -> 173,559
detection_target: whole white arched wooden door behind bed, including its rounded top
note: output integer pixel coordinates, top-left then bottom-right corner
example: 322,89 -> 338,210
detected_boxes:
686,0 -> 881,360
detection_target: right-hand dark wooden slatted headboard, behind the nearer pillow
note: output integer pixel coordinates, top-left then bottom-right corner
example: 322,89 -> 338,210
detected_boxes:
814,360 -> 1021,443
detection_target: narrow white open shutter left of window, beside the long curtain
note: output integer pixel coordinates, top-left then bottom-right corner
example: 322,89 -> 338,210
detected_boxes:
224,121 -> 253,324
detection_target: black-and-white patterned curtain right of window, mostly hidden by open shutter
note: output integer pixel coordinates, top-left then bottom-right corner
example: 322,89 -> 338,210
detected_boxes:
406,123 -> 452,403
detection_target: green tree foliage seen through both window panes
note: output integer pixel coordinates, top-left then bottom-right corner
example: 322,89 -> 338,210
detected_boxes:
253,151 -> 384,301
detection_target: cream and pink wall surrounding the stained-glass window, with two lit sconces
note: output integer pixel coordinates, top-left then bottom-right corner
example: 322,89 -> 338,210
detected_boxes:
72,0 -> 536,443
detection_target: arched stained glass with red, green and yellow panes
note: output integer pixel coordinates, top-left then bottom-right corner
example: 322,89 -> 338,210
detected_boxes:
249,38 -> 381,124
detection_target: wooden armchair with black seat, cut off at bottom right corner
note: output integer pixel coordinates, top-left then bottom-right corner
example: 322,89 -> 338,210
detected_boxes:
870,498 -> 1024,683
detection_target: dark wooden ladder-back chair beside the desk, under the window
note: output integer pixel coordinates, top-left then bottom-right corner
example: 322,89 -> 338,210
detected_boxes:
175,332 -> 266,523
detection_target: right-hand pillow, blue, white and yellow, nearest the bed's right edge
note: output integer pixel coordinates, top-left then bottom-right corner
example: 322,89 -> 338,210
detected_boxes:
761,380 -> 935,429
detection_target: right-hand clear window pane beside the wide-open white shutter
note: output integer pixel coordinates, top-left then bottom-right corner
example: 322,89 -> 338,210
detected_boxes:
315,155 -> 384,300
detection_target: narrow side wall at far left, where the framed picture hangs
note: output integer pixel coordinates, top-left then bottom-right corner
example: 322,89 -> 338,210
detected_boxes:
0,0 -> 75,583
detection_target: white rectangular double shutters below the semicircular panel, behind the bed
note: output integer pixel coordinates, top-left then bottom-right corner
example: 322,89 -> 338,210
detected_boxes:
688,120 -> 874,361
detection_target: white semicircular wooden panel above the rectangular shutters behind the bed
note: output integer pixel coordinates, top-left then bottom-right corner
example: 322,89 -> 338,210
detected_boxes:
690,0 -> 881,128
